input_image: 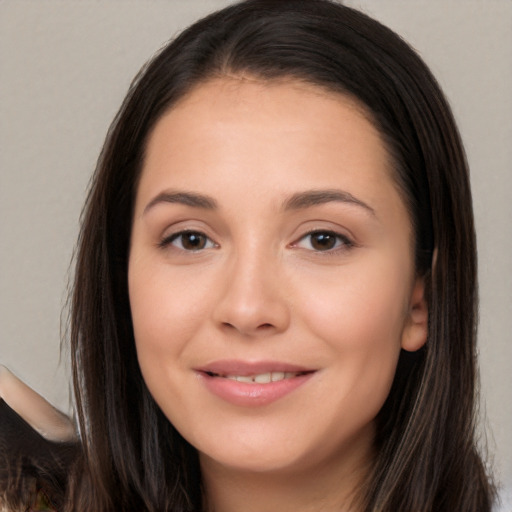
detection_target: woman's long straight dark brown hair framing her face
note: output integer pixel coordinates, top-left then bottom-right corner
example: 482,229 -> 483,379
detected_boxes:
68,0 -> 493,512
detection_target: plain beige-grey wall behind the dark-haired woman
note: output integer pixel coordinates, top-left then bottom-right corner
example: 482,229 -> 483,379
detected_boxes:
0,0 -> 512,512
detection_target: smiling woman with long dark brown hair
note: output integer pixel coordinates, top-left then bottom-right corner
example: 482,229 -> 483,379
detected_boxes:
0,0 -> 493,511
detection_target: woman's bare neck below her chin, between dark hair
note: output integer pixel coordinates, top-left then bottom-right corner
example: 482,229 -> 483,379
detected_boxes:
200,430 -> 372,512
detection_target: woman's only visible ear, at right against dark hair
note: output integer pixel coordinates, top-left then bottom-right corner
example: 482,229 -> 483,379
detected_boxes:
401,277 -> 428,352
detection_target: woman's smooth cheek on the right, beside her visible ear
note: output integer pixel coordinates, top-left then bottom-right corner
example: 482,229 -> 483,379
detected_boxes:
297,256 -> 409,396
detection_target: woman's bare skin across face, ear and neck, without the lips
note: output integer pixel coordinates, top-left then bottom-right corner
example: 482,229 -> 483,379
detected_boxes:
128,77 -> 428,512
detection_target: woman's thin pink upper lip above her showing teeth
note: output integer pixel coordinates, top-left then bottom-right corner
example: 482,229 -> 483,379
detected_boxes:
195,359 -> 316,376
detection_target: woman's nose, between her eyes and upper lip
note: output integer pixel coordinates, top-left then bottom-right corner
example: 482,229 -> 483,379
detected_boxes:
214,253 -> 290,337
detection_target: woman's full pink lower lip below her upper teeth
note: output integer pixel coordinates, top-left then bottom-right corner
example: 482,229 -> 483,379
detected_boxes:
198,372 -> 314,407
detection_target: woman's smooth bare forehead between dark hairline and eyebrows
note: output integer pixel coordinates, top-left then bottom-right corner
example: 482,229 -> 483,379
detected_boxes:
137,77 -> 408,221
